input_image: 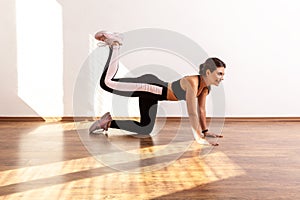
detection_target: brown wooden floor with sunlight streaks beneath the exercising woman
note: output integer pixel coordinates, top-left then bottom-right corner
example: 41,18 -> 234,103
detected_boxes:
0,120 -> 300,200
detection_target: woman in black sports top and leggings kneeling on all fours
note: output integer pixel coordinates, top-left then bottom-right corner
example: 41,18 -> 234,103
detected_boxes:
89,31 -> 226,146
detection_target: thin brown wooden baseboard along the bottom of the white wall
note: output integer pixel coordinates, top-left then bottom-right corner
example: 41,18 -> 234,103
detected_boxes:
0,116 -> 300,122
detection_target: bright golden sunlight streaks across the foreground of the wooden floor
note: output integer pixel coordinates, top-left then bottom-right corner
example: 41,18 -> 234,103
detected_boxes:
1,152 -> 245,199
